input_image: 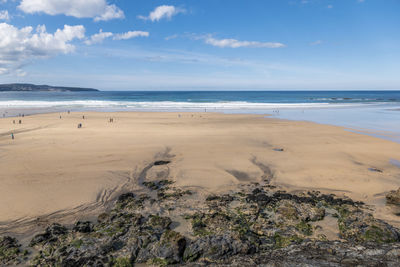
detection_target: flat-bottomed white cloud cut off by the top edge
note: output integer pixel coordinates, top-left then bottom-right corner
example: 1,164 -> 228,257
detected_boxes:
18,0 -> 125,21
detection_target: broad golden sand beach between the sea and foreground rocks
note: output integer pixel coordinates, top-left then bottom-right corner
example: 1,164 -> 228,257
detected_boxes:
0,112 -> 400,233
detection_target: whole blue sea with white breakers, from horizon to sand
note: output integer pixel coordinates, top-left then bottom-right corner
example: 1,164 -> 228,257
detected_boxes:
0,91 -> 400,142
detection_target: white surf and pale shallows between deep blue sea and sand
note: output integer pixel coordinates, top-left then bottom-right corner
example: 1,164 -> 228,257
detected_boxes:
0,101 -> 400,147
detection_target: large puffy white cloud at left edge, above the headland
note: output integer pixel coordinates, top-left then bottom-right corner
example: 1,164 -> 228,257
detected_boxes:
0,23 -> 85,74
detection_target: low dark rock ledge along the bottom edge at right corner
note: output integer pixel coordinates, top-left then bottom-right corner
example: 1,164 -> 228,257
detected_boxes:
217,241 -> 400,267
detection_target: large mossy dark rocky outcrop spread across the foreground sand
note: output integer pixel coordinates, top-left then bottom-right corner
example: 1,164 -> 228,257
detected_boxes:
0,180 -> 400,266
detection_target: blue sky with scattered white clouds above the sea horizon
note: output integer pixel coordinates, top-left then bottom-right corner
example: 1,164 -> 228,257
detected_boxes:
0,0 -> 400,90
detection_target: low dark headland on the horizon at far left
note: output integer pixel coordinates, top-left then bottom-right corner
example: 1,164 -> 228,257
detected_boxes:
0,83 -> 99,92
